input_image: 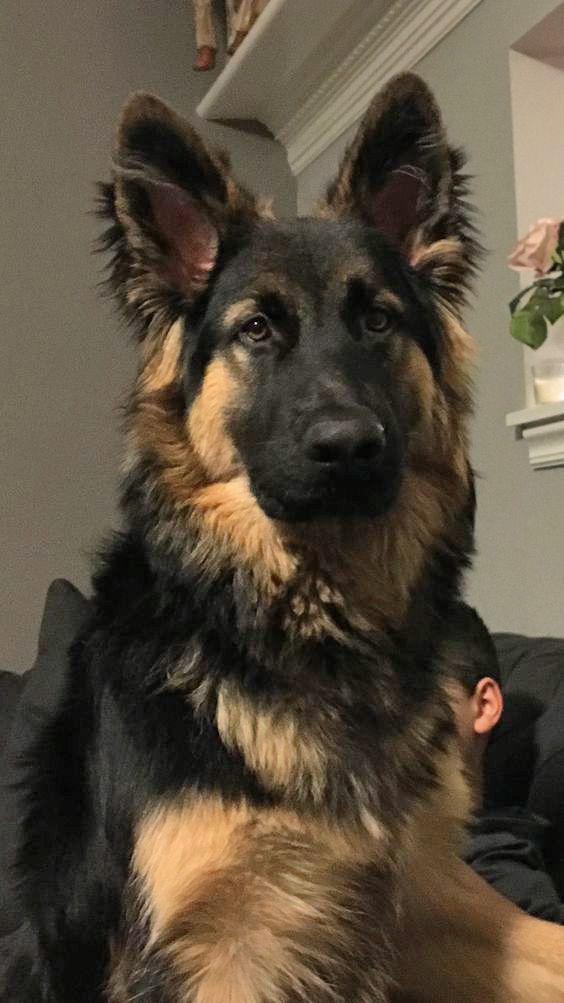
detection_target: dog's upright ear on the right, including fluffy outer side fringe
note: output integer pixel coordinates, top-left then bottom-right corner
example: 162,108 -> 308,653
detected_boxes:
326,73 -> 478,300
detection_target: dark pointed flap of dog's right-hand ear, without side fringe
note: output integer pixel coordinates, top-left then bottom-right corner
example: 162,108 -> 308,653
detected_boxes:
327,73 -> 451,248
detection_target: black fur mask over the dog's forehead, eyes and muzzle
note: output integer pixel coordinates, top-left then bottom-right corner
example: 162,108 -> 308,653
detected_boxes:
186,220 -> 441,521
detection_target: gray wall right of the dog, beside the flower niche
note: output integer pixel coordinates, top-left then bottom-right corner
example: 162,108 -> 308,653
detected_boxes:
298,0 -> 564,636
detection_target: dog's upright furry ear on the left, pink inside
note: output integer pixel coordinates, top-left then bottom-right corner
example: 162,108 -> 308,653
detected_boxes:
104,93 -> 254,330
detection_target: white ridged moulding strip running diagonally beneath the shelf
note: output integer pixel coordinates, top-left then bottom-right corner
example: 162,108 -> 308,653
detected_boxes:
276,0 -> 481,175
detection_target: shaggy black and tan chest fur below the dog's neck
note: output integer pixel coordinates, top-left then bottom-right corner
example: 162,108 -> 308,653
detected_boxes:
88,541 -> 457,1003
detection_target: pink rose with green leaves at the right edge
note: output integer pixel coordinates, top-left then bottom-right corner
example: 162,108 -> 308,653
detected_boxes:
508,220 -> 564,348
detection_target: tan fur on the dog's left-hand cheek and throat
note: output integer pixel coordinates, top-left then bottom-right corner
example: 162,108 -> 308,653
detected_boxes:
127,324 -> 295,596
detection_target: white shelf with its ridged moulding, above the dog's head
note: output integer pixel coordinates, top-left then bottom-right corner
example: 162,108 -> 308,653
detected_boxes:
198,0 -> 481,175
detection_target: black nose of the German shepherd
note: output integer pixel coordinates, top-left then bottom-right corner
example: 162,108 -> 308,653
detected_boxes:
304,415 -> 385,471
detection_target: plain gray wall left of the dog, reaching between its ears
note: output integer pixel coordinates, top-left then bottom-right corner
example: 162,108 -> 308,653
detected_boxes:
0,0 -> 295,670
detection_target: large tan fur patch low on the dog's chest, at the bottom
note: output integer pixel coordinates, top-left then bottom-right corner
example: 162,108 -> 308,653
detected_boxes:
133,797 -> 385,1003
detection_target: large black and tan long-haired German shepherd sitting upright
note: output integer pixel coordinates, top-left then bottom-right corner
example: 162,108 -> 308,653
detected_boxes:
13,75 -> 564,1003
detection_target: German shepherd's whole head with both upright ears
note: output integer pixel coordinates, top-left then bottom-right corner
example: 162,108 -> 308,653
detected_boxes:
101,75 -> 476,585
